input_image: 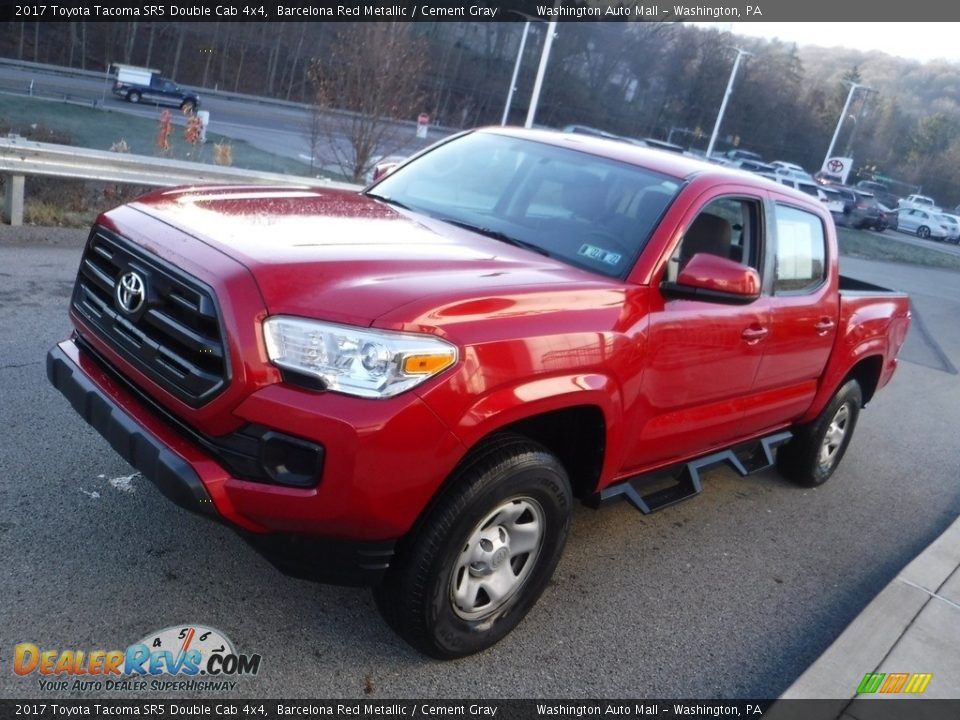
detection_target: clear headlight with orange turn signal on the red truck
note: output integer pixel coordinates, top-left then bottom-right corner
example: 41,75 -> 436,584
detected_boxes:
263,315 -> 457,398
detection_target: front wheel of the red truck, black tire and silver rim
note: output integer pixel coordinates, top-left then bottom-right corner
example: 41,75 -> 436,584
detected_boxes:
374,435 -> 573,660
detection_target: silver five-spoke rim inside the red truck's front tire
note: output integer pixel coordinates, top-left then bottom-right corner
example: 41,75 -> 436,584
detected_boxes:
450,497 -> 545,620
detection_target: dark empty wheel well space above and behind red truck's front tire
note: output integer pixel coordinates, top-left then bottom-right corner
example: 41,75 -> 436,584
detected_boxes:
496,405 -> 607,498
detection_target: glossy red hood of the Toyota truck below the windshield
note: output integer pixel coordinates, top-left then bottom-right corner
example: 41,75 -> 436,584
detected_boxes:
132,185 -> 611,325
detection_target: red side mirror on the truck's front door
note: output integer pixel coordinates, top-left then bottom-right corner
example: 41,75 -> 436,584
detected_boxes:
660,253 -> 760,303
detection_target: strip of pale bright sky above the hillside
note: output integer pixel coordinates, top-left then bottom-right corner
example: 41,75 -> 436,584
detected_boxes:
694,22 -> 960,62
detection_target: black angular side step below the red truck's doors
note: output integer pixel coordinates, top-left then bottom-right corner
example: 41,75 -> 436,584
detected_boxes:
594,431 -> 793,515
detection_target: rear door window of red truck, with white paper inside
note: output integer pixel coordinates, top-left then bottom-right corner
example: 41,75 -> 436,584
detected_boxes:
774,205 -> 827,292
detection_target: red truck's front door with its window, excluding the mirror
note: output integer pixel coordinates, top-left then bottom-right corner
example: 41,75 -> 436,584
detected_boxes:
623,193 -> 770,471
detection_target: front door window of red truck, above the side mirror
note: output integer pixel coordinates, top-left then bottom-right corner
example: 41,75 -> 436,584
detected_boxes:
667,197 -> 761,281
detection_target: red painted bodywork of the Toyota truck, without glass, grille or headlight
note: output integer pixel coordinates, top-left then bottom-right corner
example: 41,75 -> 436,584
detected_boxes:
61,130 -> 908,539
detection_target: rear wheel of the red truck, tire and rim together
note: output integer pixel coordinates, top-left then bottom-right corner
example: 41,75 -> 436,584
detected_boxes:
777,380 -> 863,487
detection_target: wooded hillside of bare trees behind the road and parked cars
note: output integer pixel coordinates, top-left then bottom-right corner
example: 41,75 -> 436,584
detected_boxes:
0,21 -> 960,200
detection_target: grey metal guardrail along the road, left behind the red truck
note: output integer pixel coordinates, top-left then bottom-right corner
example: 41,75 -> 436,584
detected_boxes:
0,136 -> 358,225
